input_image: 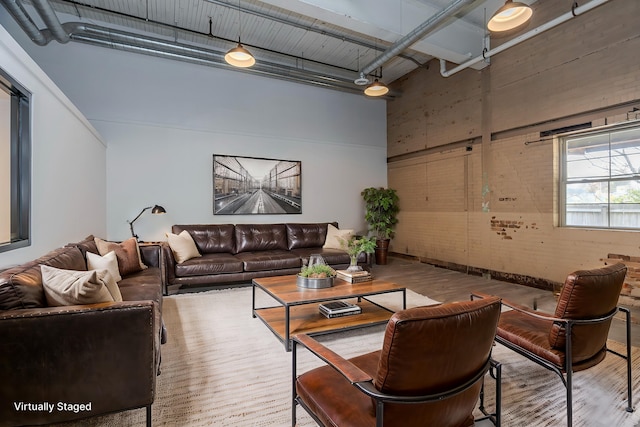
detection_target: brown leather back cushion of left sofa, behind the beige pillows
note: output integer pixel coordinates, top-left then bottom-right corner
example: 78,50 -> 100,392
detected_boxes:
0,247 -> 87,310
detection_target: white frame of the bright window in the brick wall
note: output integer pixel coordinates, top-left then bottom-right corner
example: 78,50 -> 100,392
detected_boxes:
556,120 -> 640,231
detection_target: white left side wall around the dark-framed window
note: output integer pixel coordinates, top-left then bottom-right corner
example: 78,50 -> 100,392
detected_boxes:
0,27 -> 106,268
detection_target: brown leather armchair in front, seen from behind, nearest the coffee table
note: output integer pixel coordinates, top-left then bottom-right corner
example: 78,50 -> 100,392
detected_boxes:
292,298 -> 500,427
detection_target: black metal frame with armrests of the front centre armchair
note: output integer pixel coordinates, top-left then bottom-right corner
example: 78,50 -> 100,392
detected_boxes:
291,335 -> 502,427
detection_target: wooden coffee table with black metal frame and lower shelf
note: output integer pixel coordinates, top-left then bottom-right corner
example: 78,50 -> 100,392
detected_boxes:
251,275 -> 407,351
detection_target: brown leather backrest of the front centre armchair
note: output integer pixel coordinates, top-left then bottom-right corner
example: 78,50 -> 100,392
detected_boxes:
375,297 -> 500,426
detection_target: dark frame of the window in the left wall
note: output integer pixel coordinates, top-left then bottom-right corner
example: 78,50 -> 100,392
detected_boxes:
0,68 -> 32,253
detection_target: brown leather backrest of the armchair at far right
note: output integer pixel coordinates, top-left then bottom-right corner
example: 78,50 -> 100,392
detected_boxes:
549,263 -> 627,364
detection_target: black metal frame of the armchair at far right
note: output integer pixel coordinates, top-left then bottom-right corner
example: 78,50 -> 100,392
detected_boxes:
471,294 -> 635,427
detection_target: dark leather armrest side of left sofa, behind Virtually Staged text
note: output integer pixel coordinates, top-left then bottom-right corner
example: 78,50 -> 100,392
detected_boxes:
0,301 -> 160,425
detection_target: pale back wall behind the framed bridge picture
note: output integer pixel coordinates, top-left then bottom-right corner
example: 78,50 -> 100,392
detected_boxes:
0,15 -> 387,244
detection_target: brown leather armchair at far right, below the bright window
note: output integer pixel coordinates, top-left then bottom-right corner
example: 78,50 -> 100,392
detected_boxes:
472,264 -> 634,426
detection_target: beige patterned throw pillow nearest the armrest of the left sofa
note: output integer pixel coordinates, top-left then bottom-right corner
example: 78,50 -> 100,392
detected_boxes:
40,265 -> 122,307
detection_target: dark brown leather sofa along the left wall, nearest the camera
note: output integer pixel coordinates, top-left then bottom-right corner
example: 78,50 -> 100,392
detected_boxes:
0,236 -> 168,426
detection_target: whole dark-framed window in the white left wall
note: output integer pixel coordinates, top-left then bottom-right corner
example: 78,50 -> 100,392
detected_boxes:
0,69 -> 31,252
